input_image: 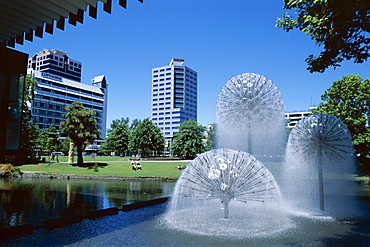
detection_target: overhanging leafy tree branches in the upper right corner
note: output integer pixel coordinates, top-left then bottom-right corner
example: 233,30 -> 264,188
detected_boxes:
276,0 -> 370,73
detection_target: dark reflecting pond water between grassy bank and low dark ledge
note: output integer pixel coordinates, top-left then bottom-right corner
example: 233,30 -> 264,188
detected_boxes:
0,179 -> 174,230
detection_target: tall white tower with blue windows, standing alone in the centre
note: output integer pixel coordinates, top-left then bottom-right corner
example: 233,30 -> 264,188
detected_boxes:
151,58 -> 198,146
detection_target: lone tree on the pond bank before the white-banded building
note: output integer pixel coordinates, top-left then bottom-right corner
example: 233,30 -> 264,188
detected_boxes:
60,102 -> 99,166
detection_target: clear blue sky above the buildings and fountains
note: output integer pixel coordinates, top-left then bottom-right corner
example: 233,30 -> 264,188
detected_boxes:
16,0 -> 370,126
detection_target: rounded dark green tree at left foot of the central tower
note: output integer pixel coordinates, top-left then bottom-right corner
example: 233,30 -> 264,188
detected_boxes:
129,118 -> 164,157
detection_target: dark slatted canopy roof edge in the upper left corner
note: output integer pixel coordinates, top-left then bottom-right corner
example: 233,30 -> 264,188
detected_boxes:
0,0 -> 143,47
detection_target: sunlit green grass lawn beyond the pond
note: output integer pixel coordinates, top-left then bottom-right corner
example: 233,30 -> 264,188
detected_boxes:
19,156 -> 189,178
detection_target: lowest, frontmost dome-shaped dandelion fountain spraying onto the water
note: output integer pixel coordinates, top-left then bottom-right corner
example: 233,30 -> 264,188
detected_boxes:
165,149 -> 294,238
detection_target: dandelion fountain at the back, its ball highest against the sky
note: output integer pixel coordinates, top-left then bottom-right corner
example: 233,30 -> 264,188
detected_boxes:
216,73 -> 285,159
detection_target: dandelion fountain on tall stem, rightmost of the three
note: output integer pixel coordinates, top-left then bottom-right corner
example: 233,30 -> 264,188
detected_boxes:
284,114 -> 355,216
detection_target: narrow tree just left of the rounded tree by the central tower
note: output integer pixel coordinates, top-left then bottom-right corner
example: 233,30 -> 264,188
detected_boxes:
103,118 -> 130,153
